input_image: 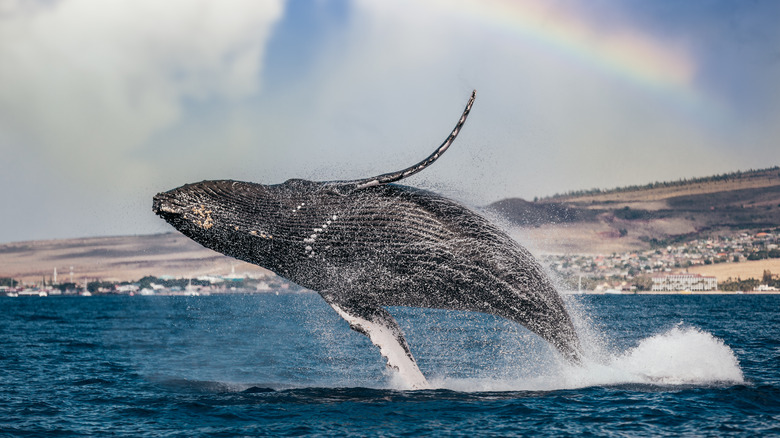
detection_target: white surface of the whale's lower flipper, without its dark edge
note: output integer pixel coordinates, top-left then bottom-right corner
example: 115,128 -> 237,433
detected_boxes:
331,304 -> 431,389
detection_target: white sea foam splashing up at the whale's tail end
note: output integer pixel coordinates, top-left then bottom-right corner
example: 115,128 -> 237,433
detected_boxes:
424,327 -> 744,392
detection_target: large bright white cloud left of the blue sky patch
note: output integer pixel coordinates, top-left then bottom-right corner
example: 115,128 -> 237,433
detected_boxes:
0,0 -> 282,186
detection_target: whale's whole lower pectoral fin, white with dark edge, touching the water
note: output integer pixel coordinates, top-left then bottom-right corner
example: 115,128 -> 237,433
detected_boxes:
325,297 -> 430,389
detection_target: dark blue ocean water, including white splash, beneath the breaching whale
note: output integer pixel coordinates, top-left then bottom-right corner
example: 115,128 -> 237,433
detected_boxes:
0,293 -> 780,437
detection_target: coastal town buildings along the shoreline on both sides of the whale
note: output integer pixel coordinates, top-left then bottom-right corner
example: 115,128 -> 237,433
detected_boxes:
0,228 -> 780,297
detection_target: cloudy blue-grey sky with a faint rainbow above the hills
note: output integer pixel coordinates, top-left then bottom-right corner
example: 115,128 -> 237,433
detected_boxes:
0,0 -> 780,243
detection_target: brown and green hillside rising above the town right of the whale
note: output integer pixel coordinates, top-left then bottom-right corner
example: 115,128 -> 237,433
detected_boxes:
487,167 -> 780,254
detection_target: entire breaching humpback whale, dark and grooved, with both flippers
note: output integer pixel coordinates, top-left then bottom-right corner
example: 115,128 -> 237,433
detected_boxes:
153,91 -> 580,388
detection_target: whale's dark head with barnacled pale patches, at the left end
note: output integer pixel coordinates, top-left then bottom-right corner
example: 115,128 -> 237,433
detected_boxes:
152,180 -> 274,258
